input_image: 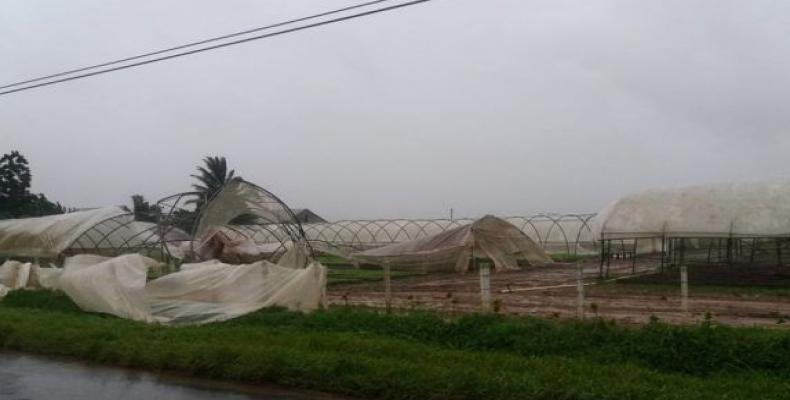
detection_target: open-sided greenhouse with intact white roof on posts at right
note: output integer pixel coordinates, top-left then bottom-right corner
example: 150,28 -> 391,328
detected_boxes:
593,182 -> 790,271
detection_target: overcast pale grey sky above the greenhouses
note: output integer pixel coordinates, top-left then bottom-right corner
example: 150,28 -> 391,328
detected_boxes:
0,0 -> 790,219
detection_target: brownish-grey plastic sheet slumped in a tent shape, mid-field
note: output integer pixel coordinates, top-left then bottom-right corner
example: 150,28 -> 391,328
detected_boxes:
351,215 -> 551,272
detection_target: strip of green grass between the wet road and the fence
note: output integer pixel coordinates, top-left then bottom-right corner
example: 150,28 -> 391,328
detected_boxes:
0,291 -> 790,399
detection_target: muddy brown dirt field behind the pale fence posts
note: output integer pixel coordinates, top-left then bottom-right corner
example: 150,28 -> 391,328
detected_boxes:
329,261 -> 790,328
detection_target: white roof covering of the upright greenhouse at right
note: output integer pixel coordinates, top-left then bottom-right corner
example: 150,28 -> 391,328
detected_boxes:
594,182 -> 790,240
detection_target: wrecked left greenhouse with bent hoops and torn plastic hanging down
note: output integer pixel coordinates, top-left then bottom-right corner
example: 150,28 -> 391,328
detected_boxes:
0,179 -> 326,324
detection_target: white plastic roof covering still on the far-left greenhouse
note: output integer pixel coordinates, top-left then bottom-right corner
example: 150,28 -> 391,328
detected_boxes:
0,207 -> 134,258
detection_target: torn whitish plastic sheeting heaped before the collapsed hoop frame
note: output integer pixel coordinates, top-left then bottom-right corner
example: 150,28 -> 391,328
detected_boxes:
59,254 -> 326,324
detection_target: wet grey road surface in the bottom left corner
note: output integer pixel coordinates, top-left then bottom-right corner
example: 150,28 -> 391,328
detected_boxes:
0,352 -> 352,400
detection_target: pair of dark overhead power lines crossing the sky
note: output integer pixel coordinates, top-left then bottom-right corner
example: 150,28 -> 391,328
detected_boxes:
0,0 -> 431,96
